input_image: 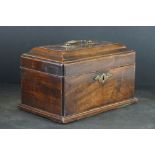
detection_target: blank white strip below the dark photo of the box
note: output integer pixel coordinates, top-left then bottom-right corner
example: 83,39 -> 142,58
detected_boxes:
0,129 -> 155,155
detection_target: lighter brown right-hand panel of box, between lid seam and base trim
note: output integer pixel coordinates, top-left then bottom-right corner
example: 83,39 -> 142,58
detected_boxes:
64,65 -> 135,116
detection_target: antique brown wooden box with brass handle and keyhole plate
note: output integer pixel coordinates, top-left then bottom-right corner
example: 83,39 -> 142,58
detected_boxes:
19,40 -> 137,123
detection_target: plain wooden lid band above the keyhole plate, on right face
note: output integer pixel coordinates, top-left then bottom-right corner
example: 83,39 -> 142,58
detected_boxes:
64,51 -> 135,76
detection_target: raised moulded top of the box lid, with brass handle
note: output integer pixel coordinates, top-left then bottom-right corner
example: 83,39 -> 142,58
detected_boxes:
24,40 -> 130,63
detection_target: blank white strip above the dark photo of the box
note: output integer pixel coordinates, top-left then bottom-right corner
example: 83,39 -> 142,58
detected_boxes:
0,0 -> 155,26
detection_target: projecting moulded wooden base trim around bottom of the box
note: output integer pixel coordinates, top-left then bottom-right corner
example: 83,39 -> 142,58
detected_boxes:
18,98 -> 138,123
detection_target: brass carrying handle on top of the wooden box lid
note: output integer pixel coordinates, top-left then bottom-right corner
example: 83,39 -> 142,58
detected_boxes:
65,40 -> 93,46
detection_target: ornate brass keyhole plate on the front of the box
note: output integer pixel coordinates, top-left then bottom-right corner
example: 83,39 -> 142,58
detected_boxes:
94,73 -> 112,84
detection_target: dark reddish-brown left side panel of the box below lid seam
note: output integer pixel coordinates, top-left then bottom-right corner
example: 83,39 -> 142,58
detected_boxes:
21,68 -> 62,114
